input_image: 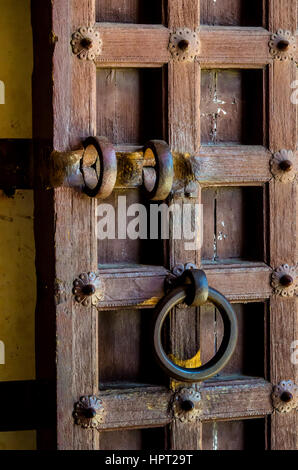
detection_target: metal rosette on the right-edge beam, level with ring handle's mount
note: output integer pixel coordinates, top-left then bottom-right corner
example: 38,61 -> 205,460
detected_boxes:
271,264 -> 298,297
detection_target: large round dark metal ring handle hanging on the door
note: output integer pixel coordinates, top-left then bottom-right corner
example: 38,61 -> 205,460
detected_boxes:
154,286 -> 238,382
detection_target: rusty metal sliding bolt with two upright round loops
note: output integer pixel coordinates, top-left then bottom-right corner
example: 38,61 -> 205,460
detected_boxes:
46,136 -> 173,200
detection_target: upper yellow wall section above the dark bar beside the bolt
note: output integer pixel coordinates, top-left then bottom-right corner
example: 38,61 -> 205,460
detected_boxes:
0,0 -> 33,139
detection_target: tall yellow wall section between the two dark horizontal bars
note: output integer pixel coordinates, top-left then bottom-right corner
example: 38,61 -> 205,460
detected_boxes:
0,190 -> 36,380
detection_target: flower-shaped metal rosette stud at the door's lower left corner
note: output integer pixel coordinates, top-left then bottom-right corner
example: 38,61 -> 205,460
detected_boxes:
73,395 -> 105,429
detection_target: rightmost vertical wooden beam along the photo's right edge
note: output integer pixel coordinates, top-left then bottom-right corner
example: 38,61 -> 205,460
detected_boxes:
269,0 -> 298,450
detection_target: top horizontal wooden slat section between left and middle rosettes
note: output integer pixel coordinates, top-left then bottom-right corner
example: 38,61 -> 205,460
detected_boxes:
96,23 -> 170,67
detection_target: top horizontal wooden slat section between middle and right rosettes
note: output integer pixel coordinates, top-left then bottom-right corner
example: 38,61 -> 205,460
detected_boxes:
198,26 -> 272,66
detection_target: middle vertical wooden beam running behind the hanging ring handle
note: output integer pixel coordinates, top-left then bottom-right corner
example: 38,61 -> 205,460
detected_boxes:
168,0 -> 202,450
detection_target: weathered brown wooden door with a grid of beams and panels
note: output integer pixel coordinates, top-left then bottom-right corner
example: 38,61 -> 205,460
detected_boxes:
32,0 -> 298,450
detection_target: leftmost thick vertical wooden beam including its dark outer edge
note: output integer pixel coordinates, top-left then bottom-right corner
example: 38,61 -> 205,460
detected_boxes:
32,0 -> 98,449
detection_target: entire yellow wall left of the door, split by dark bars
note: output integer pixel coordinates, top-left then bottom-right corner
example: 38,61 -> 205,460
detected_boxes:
0,0 -> 36,449
